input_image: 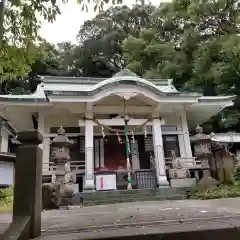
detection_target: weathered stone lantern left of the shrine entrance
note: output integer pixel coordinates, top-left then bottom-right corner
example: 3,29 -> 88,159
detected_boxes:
51,127 -> 78,205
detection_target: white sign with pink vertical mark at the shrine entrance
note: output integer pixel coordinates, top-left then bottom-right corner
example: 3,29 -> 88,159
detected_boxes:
96,174 -> 117,191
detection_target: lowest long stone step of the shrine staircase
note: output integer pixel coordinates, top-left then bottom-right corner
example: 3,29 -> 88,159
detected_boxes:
84,195 -> 186,206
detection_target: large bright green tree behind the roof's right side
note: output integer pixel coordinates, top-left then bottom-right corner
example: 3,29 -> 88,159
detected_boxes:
122,0 -> 240,131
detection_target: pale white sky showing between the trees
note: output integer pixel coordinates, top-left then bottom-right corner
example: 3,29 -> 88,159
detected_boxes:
40,0 -> 161,44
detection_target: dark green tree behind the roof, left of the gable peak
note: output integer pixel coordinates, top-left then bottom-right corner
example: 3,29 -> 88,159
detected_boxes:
75,4 -> 156,77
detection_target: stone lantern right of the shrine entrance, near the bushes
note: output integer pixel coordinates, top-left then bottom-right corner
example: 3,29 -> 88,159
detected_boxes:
190,126 -> 217,187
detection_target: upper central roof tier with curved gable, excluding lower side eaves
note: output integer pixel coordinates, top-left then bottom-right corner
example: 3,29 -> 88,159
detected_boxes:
43,69 -> 178,96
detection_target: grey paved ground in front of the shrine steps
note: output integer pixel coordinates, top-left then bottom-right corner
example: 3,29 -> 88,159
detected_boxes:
0,198 -> 240,240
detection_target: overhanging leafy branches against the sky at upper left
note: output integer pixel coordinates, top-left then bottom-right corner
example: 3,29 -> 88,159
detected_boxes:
0,0 -> 134,81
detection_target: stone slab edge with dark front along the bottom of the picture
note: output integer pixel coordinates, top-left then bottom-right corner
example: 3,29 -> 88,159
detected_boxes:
38,219 -> 240,240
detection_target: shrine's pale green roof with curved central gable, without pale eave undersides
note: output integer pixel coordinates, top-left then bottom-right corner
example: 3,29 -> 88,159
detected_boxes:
0,69 -> 235,108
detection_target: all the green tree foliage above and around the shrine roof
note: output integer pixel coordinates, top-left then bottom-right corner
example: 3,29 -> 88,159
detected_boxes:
0,0 -> 240,131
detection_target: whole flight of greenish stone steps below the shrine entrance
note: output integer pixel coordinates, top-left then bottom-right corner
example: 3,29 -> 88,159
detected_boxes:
73,188 -> 189,206
